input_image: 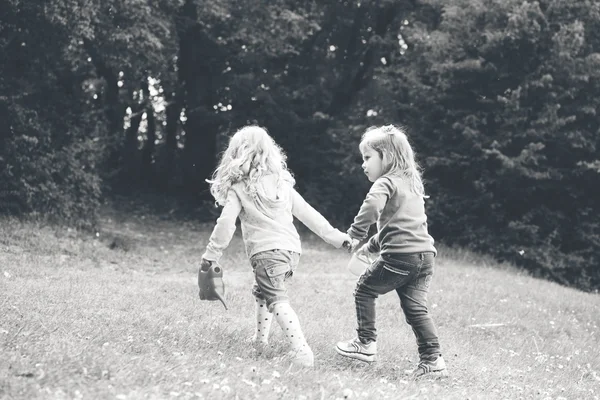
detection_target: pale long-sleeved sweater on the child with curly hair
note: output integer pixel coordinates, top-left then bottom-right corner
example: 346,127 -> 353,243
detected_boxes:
202,175 -> 348,261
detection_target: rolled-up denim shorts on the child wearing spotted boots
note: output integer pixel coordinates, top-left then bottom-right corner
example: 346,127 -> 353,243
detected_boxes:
250,249 -> 300,312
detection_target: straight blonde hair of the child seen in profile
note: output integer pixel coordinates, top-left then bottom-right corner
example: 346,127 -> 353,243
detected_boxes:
359,125 -> 429,198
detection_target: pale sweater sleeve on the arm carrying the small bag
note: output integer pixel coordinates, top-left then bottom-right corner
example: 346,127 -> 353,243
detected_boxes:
202,190 -> 242,262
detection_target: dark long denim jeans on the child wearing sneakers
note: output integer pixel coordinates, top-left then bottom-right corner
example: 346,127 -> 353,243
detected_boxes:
354,252 -> 441,360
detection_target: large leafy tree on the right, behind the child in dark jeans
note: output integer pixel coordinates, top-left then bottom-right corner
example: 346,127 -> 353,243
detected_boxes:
391,1 -> 600,289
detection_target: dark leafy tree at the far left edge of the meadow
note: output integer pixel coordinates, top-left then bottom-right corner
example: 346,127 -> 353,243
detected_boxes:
0,0 -> 103,225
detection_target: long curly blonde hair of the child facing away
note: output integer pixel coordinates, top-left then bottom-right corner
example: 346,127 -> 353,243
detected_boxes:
206,125 -> 295,206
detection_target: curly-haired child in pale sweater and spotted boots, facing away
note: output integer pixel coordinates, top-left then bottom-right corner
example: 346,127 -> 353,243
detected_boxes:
201,125 -> 350,367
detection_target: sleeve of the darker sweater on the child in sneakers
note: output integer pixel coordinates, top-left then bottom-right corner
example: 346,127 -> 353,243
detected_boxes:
348,178 -> 394,241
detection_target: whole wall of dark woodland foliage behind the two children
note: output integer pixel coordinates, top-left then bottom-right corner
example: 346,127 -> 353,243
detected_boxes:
0,0 -> 600,289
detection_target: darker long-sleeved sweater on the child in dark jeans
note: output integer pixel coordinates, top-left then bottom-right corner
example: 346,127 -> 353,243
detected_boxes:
348,176 -> 437,254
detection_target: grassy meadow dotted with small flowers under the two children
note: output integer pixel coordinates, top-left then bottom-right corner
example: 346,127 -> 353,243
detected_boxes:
0,212 -> 600,399
